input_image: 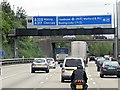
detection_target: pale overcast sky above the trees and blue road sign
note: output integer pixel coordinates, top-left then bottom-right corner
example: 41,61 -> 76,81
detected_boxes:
7,0 -> 118,16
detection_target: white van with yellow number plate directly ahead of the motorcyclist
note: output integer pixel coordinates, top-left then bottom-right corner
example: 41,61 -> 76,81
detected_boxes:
60,57 -> 85,82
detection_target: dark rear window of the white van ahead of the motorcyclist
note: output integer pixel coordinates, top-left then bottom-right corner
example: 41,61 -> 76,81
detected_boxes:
65,59 -> 82,67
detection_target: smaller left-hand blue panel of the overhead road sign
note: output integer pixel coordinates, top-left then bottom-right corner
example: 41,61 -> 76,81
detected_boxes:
33,16 -> 56,26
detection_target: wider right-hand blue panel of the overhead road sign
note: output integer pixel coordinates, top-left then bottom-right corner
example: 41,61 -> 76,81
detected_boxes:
58,15 -> 111,26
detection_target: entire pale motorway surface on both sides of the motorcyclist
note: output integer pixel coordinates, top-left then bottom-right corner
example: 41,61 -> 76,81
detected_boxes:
0,61 -> 118,90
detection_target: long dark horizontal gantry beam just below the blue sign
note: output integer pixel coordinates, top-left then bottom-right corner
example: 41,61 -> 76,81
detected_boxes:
15,28 -> 115,36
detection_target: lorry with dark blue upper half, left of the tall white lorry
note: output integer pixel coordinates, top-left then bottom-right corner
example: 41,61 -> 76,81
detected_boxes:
55,47 -> 68,64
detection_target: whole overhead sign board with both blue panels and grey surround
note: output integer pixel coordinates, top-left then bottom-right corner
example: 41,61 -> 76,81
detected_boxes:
27,15 -> 112,29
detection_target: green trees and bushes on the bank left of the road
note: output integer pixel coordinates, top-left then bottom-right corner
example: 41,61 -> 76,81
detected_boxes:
0,1 -> 42,58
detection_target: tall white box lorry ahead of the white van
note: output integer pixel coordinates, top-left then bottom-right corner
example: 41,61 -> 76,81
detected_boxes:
71,41 -> 88,65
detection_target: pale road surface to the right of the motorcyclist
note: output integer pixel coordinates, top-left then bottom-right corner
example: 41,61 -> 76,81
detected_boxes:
86,62 -> 118,88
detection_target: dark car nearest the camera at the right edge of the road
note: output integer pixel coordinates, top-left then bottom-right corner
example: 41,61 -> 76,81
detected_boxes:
100,61 -> 120,78
